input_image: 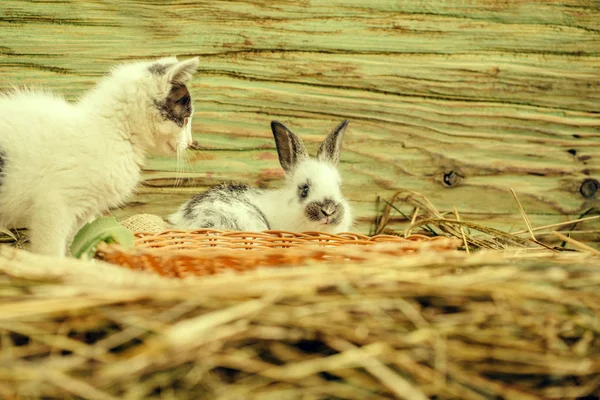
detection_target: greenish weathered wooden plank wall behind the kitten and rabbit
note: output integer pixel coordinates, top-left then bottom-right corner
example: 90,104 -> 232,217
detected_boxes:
0,0 -> 600,240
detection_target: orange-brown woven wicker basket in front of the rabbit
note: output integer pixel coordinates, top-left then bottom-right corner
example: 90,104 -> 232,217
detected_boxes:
96,229 -> 460,278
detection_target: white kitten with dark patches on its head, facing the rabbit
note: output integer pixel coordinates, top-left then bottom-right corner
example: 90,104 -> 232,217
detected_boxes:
0,57 -> 199,256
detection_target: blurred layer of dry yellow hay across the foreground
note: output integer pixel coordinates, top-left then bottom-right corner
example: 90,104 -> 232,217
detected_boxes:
0,246 -> 600,400
